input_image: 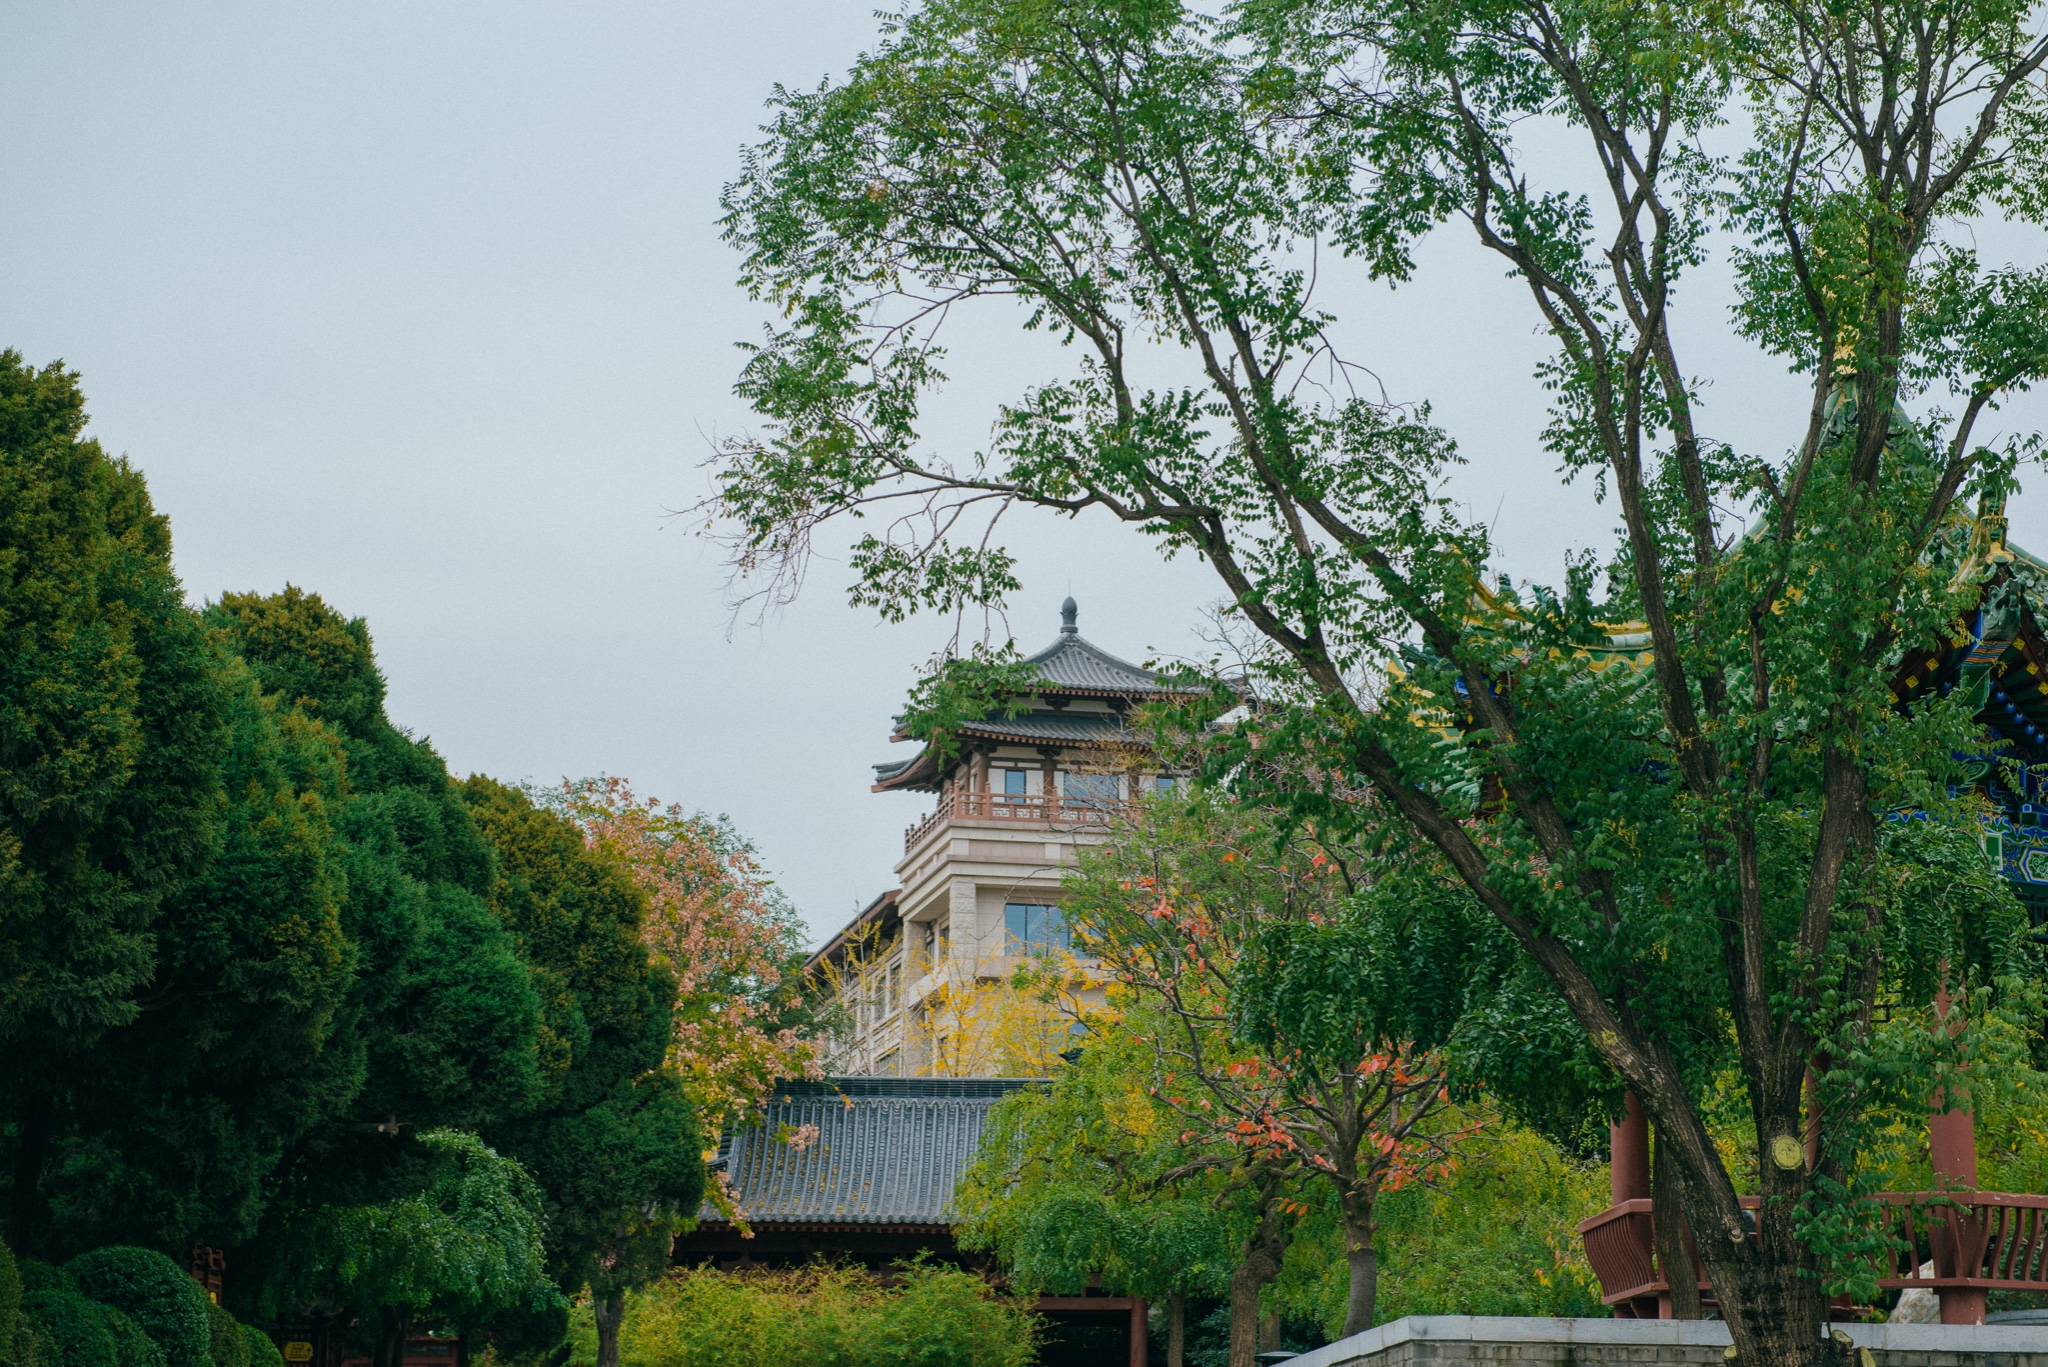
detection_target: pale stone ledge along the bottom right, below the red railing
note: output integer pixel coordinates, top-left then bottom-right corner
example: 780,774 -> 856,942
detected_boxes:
1288,1316 -> 2048,1367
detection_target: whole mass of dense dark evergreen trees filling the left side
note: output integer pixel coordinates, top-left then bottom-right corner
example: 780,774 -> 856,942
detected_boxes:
0,353 -> 705,1367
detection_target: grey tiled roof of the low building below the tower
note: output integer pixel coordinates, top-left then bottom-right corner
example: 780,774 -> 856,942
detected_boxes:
702,1078 -> 1030,1224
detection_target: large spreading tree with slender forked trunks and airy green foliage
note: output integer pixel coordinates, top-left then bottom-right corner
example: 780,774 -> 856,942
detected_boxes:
713,0 -> 2048,1365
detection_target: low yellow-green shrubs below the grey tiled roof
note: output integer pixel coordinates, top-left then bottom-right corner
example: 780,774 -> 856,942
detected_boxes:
571,1262 -> 1038,1367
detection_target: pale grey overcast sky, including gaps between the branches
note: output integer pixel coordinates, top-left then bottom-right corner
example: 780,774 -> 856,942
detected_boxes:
0,0 -> 2048,935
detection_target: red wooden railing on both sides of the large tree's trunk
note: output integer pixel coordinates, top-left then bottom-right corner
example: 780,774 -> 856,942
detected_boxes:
1579,1191 -> 2048,1318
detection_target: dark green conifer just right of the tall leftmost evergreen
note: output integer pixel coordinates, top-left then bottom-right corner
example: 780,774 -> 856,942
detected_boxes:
24,656 -> 360,1250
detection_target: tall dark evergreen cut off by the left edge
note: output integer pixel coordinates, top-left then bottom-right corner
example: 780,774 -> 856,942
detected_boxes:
0,350 -> 225,1252
